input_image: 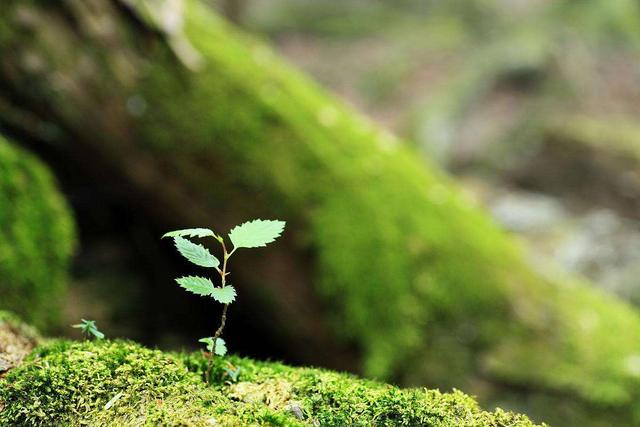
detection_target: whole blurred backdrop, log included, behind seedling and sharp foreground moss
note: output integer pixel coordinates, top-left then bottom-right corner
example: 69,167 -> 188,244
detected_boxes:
0,0 -> 640,426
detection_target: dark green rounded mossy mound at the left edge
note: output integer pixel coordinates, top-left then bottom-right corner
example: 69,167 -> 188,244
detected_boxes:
0,136 -> 74,326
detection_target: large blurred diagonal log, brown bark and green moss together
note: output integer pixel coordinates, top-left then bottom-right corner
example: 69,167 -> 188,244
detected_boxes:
0,0 -> 640,425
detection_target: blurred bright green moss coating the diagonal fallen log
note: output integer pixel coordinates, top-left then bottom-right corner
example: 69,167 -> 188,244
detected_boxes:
150,2 -> 640,414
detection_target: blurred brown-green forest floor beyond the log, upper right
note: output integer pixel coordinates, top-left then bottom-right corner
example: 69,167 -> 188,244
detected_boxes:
242,0 -> 640,303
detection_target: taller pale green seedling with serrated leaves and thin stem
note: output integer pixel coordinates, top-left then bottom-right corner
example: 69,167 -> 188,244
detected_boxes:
162,219 -> 285,383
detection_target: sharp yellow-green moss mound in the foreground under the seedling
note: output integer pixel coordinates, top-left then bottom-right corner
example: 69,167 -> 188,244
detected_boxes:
0,341 -> 533,427
